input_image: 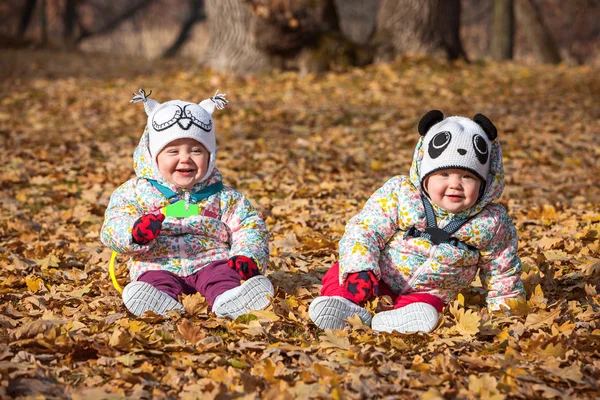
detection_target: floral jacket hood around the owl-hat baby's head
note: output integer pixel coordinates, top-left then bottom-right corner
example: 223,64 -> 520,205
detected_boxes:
133,128 -> 223,193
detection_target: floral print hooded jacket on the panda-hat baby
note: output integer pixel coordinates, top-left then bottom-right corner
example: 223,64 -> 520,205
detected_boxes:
339,134 -> 524,310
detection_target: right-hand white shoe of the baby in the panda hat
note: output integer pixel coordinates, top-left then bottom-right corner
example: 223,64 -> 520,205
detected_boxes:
371,303 -> 439,333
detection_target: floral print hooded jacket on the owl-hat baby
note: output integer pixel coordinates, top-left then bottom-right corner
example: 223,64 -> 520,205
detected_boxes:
100,130 -> 269,280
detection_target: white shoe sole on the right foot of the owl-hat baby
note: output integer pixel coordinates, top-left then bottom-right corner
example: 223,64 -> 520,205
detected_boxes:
212,275 -> 275,319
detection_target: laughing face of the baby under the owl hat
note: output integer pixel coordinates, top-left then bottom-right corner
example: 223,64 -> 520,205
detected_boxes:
156,138 -> 210,189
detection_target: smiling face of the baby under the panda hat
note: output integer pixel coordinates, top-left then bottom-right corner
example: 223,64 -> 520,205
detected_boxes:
425,169 -> 481,213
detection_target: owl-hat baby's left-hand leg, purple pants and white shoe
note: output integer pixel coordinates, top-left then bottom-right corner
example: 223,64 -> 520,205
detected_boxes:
123,270 -> 185,316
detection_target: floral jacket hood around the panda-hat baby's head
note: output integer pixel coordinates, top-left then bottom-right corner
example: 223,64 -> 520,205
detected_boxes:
409,133 -> 504,218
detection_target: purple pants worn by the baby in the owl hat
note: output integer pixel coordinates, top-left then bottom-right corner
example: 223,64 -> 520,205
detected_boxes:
137,260 -> 242,307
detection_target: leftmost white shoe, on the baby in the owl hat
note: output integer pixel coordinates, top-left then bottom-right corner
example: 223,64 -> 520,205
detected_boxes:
123,281 -> 183,317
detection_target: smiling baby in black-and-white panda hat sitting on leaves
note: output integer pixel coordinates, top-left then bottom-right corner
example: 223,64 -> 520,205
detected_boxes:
309,110 -> 525,333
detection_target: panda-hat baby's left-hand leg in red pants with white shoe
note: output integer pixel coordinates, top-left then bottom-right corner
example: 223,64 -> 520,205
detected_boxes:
308,263 -> 371,329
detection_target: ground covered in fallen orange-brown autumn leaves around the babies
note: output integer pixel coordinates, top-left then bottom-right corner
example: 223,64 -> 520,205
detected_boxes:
0,51 -> 600,399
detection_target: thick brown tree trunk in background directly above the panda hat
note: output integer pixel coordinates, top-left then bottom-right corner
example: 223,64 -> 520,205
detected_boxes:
375,0 -> 467,61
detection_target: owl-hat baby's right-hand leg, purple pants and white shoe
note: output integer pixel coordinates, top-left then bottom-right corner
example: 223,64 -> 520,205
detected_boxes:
185,260 -> 274,318
